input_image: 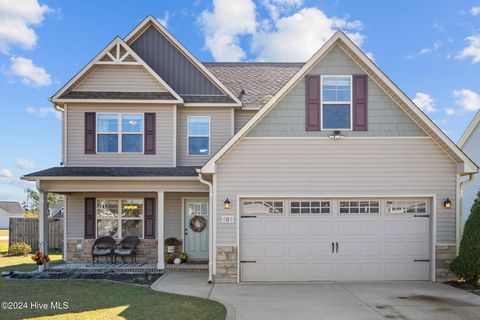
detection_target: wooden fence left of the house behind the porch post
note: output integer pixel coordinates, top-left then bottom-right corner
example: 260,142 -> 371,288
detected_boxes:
8,218 -> 64,250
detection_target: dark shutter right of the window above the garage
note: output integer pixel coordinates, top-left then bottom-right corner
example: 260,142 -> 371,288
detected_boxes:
353,75 -> 368,131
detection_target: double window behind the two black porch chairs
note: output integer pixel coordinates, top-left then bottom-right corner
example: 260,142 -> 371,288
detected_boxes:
97,199 -> 144,238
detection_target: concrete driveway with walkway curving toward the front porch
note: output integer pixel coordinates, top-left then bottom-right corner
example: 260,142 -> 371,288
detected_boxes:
152,273 -> 480,320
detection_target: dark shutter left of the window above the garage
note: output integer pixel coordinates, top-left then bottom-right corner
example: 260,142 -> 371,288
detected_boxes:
305,76 -> 320,131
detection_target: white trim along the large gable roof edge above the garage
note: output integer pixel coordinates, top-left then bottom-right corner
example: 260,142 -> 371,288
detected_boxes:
201,31 -> 478,174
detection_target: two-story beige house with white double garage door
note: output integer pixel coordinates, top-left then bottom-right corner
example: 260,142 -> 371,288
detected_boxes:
23,17 -> 478,282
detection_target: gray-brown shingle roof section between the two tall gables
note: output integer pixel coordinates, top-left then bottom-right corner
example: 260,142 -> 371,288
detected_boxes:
203,62 -> 304,108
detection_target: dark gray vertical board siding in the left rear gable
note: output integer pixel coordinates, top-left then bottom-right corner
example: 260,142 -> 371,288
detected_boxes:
130,27 -> 224,95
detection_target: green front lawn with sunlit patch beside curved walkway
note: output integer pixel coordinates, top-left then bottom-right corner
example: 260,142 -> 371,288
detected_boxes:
0,280 -> 225,320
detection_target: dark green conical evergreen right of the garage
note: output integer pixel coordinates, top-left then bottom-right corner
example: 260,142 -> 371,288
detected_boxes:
450,191 -> 480,283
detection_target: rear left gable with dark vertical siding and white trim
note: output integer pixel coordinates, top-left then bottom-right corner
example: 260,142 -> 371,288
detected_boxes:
125,16 -> 241,106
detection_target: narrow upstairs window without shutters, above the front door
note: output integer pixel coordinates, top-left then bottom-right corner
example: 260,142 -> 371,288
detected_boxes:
187,117 -> 210,156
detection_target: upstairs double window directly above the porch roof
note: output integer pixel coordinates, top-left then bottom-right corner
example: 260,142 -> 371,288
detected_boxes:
97,113 -> 143,153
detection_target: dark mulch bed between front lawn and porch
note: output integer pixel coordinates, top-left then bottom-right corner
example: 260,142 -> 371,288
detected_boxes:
5,272 -> 163,286
